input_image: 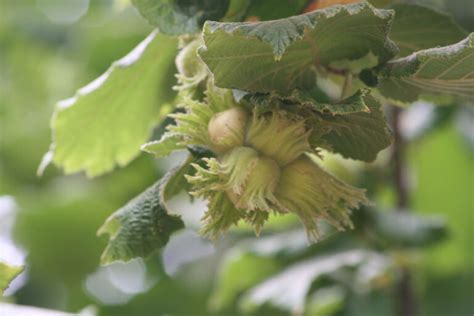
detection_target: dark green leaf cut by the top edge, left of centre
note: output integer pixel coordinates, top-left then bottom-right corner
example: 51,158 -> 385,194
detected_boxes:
132,0 -> 229,35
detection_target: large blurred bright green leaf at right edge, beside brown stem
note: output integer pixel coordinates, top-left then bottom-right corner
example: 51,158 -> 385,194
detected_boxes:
409,124 -> 474,272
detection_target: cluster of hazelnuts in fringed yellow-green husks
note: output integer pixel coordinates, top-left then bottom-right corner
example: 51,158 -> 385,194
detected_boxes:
178,99 -> 368,241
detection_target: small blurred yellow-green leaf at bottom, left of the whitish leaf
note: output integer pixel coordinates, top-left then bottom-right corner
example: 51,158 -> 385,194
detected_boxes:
210,251 -> 281,311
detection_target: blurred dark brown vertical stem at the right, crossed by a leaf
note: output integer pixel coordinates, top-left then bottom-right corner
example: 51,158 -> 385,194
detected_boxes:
392,106 -> 417,316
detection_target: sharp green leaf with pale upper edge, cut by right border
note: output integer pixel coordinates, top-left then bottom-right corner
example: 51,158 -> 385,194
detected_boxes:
378,33 -> 474,104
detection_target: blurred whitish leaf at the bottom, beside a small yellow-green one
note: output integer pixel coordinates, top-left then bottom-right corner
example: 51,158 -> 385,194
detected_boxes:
241,250 -> 373,314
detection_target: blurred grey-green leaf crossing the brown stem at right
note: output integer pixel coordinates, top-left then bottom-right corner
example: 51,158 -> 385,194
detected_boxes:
370,211 -> 447,247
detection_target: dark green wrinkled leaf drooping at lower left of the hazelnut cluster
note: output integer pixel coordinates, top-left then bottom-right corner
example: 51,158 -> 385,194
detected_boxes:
98,168 -> 188,264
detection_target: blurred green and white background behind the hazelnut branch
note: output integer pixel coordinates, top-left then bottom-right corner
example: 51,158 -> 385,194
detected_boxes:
0,0 -> 474,316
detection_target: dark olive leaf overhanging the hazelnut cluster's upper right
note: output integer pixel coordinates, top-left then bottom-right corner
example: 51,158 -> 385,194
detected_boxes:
250,90 -> 392,162
